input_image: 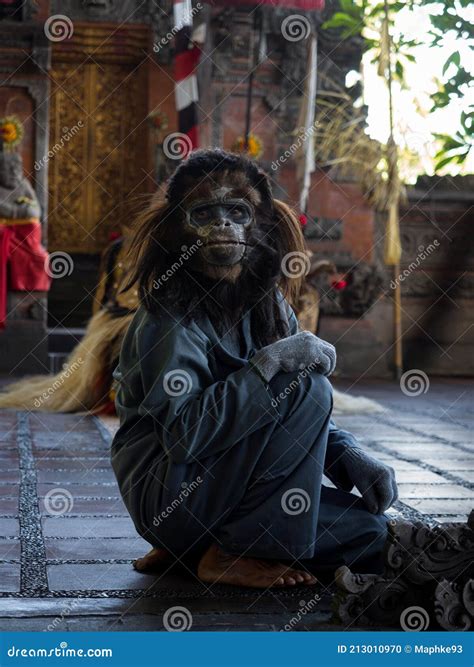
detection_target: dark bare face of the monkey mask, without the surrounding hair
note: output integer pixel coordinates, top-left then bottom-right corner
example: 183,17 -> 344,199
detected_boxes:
185,198 -> 255,267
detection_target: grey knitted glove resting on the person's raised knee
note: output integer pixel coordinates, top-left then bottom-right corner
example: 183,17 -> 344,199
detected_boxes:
250,331 -> 336,382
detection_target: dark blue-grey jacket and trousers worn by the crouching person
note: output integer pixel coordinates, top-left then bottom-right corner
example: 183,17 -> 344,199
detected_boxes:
112,301 -> 386,570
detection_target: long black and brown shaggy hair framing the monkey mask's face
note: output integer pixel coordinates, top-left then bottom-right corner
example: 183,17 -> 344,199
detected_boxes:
126,150 -> 305,346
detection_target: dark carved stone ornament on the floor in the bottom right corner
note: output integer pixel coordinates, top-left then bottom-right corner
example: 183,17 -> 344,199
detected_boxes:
335,511 -> 474,630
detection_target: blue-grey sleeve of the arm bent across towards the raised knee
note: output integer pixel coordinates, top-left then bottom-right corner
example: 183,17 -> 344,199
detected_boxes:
136,314 -> 278,463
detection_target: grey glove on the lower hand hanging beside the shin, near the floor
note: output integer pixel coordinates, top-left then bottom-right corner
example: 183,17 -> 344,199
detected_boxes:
328,447 -> 398,514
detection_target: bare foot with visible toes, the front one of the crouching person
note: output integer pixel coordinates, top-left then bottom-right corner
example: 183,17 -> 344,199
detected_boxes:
198,544 -> 317,588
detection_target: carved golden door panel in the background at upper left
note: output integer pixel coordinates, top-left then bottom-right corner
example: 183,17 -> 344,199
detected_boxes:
48,62 -> 147,254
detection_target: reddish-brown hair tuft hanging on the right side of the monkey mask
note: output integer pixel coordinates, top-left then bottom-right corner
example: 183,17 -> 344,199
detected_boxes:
273,199 -> 309,305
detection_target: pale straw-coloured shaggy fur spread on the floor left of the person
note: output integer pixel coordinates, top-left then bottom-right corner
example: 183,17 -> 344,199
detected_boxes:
0,310 -> 133,412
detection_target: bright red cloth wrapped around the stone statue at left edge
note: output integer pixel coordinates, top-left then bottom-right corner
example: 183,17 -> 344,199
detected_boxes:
0,222 -> 51,329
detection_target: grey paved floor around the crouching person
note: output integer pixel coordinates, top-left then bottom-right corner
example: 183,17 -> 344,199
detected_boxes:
0,380 -> 474,631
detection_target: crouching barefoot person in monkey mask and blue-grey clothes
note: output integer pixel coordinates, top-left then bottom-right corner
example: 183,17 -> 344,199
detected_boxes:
112,150 -> 397,588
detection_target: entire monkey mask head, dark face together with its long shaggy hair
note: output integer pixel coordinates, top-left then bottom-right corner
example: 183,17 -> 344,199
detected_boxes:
129,149 -> 304,342
